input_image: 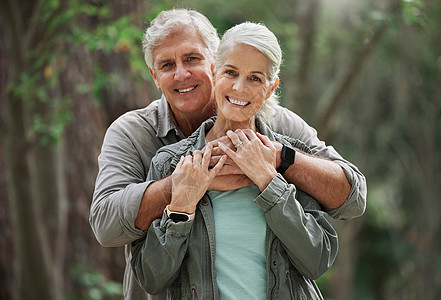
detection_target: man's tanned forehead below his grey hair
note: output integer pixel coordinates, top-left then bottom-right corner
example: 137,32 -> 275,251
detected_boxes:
152,27 -> 211,65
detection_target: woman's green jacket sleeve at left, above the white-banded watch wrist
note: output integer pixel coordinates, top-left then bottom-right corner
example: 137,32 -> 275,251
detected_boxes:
131,152 -> 194,294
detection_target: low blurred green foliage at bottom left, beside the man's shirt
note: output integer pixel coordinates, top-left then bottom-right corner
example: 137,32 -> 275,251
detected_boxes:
67,265 -> 123,300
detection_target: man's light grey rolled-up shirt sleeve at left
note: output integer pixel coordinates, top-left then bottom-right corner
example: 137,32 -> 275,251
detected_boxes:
89,116 -> 161,247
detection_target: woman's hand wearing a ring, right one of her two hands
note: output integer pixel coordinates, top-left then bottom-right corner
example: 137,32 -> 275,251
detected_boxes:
219,129 -> 277,191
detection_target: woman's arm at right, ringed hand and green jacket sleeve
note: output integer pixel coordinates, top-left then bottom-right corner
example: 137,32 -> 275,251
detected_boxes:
220,130 -> 338,279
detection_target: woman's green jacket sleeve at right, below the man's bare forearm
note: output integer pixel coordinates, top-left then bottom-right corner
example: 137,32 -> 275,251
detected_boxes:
255,174 -> 338,280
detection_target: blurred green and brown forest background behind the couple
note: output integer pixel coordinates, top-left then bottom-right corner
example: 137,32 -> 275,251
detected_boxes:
0,0 -> 441,300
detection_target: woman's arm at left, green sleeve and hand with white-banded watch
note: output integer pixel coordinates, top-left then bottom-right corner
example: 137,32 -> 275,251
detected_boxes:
131,145 -> 226,294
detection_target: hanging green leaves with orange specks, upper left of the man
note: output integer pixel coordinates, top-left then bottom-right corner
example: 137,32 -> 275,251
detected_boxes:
9,0 -> 148,145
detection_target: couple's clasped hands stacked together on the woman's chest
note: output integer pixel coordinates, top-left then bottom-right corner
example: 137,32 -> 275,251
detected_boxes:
170,129 -> 277,213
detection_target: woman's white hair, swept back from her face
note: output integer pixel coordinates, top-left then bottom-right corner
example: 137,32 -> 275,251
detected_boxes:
214,22 -> 282,122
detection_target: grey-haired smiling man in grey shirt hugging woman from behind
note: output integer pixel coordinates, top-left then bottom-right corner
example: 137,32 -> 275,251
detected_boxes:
90,9 -> 366,299
